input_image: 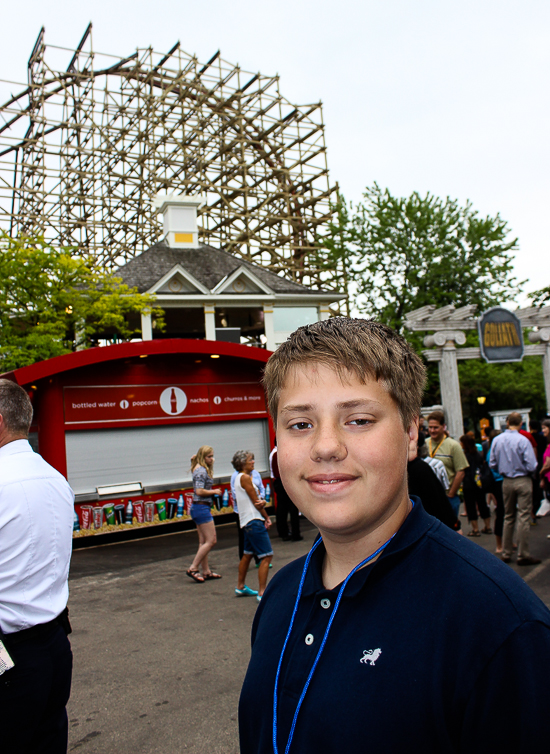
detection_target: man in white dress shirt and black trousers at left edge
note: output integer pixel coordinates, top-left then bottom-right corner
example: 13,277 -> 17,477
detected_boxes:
0,379 -> 74,754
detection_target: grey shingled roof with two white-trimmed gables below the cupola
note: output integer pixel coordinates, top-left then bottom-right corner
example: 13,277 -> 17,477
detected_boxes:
115,241 -> 344,300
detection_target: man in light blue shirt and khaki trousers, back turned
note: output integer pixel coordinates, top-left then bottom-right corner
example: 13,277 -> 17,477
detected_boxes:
489,411 -> 540,565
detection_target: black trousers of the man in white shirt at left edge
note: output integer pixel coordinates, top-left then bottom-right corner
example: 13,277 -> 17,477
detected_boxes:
0,624 -> 73,754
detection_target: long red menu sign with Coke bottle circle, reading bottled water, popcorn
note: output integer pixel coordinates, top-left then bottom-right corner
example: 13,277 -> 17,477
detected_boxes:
63,383 -> 266,426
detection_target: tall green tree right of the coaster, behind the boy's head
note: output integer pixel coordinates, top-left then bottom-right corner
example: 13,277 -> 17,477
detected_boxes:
325,183 -> 521,331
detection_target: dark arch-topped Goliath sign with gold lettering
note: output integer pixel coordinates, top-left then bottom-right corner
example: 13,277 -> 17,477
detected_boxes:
478,306 -> 523,363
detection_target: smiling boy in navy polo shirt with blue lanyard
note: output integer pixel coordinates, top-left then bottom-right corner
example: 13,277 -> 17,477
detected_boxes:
239,318 -> 550,754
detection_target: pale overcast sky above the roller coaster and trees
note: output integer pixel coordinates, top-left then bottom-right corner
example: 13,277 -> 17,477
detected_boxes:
0,0 -> 550,303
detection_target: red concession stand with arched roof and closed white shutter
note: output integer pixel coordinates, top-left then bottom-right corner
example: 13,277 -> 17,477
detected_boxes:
2,339 -> 273,547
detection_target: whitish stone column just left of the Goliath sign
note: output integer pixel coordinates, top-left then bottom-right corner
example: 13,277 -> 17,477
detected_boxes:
424,330 -> 466,440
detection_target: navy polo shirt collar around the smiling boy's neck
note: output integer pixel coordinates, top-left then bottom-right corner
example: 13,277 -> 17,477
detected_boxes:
302,495 -> 434,598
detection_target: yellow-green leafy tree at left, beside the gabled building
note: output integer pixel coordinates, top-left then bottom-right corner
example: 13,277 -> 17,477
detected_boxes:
0,234 -> 162,372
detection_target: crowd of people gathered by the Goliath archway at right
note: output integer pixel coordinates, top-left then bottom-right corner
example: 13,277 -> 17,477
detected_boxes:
418,411 -> 550,565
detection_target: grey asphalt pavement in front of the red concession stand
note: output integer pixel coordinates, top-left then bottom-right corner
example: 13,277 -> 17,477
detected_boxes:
68,508 -> 550,754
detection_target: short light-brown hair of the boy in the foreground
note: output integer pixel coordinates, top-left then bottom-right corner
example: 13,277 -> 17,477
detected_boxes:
263,317 -> 426,429
